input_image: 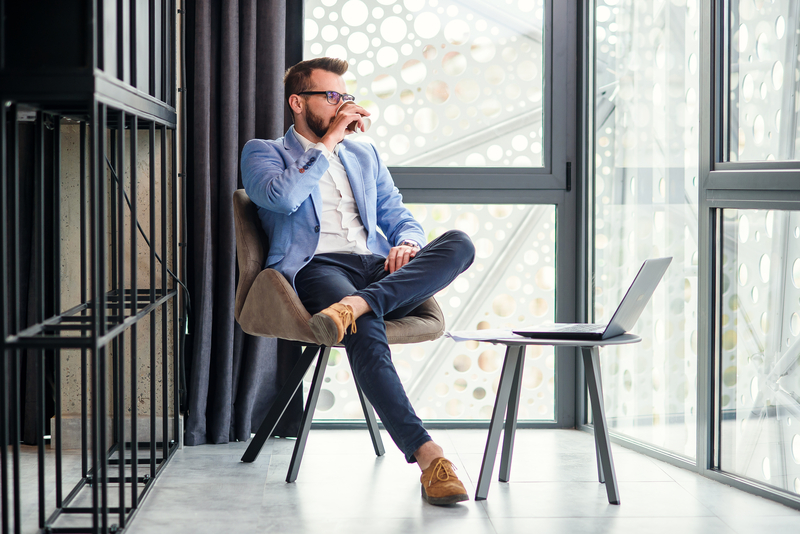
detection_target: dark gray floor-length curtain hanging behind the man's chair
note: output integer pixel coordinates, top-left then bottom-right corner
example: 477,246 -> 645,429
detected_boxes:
186,0 -> 303,445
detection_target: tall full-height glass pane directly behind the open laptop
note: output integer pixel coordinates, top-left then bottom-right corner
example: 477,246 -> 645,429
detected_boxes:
594,0 -> 700,457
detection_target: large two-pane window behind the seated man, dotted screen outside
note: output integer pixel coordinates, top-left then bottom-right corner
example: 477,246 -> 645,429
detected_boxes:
304,0 -> 575,425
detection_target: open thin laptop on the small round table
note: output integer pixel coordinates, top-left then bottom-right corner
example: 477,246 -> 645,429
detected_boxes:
514,257 -> 672,341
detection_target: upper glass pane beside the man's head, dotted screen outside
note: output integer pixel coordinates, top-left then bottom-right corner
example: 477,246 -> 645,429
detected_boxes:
304,0 -> 544,167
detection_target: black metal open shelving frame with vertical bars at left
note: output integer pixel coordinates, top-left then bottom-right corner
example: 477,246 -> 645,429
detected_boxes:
0,0 -> 183,534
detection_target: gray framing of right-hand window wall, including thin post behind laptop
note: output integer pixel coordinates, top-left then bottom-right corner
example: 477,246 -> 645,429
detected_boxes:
576,0 -> 800,509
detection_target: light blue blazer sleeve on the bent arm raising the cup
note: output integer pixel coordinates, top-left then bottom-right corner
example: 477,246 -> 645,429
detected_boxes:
242,139 -> 329,215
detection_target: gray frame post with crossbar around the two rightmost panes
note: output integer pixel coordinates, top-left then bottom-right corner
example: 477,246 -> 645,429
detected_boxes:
696,0 -> 800,508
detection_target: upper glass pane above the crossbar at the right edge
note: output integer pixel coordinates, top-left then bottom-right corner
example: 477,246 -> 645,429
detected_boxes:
728,0 -> 800,161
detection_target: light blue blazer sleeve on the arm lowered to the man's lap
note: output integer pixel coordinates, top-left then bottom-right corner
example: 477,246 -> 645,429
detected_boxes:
372,146 -> 427,247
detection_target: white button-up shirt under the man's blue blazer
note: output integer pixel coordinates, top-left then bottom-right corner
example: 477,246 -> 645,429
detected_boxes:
294,131 -> 372,255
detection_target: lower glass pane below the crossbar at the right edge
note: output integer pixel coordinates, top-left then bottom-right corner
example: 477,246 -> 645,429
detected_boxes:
717,210 -> 800,493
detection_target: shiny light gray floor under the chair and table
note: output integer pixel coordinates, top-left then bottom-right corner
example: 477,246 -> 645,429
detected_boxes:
114,429 -> 800,534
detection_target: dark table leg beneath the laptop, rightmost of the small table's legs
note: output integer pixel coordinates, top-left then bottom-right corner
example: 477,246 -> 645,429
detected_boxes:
582,347 -> 620,504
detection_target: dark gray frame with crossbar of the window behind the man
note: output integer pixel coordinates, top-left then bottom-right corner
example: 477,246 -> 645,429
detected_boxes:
304,0 -> 584,428
